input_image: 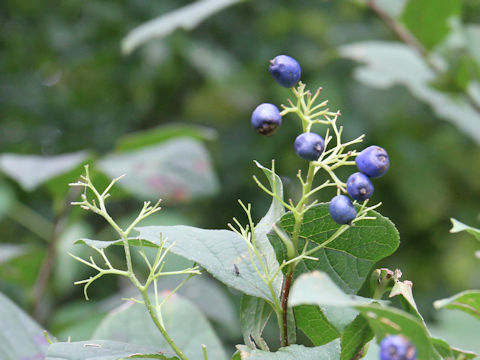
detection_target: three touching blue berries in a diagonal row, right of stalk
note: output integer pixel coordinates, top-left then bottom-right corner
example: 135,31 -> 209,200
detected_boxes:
329,145 -> 390,224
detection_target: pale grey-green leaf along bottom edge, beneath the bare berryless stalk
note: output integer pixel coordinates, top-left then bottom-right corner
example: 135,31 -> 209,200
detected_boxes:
45,340 -> 178,360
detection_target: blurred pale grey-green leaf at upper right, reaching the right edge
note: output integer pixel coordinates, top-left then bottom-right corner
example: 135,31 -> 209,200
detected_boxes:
340,41 -> 480,143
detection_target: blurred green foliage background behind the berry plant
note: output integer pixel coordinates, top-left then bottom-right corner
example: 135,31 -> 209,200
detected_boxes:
0,0 -> 480,354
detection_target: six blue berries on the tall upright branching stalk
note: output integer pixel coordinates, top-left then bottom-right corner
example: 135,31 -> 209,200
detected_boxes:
251,55 -> 390,224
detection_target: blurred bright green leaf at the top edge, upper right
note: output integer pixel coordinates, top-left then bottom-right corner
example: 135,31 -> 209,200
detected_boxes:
402,0 -> 461,49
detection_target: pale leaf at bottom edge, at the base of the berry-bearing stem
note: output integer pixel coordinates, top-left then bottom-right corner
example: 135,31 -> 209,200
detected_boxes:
237,340 -> 340,360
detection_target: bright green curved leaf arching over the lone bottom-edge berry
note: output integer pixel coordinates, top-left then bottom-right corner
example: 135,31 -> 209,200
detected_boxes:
356,304 -> 439,360
